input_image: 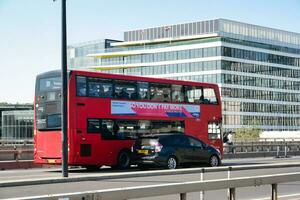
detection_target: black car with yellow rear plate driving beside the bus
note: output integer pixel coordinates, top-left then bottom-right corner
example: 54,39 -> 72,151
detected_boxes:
132,134 -> 221,169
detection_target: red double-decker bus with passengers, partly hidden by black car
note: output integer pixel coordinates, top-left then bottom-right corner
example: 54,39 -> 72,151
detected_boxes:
34,70 -> 223,168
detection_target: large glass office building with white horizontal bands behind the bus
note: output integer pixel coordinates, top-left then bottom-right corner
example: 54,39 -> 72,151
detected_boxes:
69,19 -> 300,131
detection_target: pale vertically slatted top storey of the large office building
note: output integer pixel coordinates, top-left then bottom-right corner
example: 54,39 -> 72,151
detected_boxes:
124,19 -> 300,45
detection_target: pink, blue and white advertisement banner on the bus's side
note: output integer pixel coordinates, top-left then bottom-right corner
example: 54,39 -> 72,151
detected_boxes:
111,100 -> 200,118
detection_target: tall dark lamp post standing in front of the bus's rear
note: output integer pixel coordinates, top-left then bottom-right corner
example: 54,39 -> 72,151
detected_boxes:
61,0 -> 68,177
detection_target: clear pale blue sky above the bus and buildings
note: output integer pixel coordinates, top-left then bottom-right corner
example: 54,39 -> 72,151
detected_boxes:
0,0 -> 300,103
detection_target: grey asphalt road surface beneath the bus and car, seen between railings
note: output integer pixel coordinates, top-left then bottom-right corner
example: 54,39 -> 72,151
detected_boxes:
0,157 -> 300,200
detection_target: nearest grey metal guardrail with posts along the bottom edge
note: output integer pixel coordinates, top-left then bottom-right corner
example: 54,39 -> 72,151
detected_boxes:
9,173 -> 300,200
